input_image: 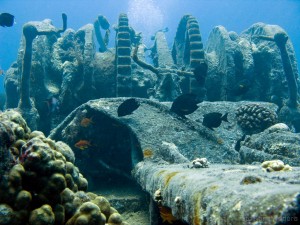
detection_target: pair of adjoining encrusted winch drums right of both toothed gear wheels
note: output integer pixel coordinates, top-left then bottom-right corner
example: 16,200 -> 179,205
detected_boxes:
206,23 -> 299,103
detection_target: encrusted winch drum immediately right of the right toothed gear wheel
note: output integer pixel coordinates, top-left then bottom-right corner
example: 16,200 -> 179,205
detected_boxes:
205,26 -> 256,101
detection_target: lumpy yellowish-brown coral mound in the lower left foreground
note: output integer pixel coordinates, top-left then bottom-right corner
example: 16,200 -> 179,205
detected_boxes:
0,110 -> 127,225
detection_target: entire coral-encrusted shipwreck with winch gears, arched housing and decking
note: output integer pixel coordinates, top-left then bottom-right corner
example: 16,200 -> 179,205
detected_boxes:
0,14 -> 300,225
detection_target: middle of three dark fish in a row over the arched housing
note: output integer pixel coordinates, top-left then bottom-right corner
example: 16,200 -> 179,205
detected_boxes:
171,93 -> 201,117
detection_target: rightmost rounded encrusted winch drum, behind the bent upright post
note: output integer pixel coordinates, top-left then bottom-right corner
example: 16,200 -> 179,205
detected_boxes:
241,23 -> 299,105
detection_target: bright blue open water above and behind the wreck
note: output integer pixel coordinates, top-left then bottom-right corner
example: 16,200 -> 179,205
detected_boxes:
0,0 -> 300,92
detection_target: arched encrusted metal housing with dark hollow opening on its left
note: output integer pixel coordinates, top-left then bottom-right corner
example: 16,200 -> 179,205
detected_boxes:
50,98 -> 298,185
